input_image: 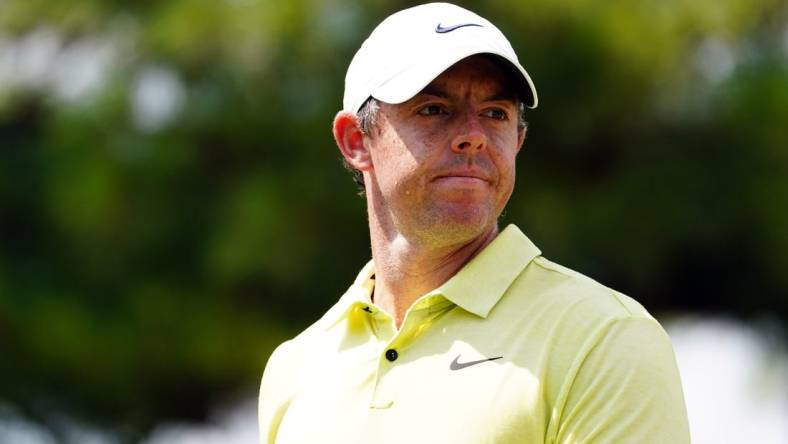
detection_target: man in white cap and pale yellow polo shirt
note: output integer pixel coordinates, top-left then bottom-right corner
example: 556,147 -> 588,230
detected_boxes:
259,3 -> 689,444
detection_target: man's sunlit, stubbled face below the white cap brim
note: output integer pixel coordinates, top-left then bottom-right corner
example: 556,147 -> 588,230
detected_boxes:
365,56 -> 524,246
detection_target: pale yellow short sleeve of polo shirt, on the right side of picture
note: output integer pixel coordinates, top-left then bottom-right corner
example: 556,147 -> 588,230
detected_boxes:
555,318 -> 690,444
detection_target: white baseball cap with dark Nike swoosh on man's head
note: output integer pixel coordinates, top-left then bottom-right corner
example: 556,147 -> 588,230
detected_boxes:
343,3 -> 538,113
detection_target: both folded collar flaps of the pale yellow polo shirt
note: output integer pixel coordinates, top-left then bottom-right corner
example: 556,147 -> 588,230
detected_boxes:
324,225 -> 542,324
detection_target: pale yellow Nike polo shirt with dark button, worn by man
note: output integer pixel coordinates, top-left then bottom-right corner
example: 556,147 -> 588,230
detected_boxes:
259,225 -> 689,444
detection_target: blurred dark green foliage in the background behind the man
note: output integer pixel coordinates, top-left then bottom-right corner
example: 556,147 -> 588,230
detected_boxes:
0,0 -> 788,440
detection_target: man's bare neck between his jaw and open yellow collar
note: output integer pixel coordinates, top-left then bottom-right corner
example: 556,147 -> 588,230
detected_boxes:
370,222 -> 498,328
